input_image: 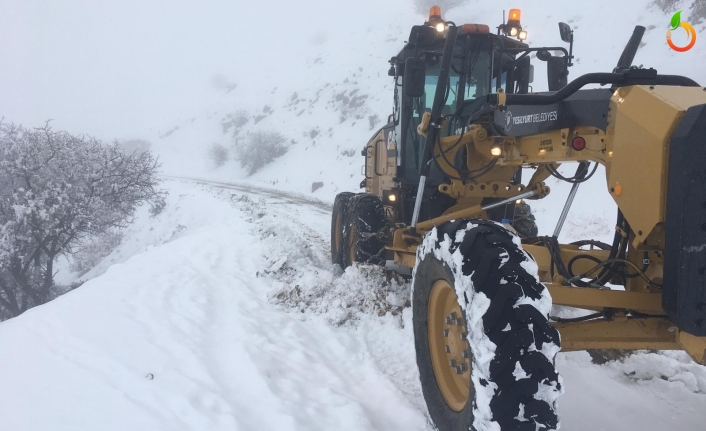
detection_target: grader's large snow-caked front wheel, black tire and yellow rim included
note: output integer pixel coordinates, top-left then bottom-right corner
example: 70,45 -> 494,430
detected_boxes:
412,220 -> 563,431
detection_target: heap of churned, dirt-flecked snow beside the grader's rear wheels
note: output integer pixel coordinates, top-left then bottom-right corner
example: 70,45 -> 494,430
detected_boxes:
230,194 -> 410,325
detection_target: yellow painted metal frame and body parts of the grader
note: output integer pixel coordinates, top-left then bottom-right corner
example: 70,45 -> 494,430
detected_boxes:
365,86 -> 706,365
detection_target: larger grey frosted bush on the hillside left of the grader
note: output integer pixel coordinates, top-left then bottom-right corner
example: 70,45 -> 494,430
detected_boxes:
235,132 -> 288,175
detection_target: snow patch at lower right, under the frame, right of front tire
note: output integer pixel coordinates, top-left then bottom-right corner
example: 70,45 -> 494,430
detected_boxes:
557,352 -> 706,431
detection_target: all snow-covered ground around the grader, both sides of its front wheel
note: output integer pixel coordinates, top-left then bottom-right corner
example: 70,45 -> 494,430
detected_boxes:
0,179 -> 706,431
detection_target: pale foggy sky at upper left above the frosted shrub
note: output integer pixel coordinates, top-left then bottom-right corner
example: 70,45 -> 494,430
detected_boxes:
0,0 -> 345,139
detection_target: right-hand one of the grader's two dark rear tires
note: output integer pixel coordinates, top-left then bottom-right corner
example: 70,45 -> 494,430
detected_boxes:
341,193 -> 387,269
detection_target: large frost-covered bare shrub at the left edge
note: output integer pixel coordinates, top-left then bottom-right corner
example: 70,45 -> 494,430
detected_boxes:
0,123 -> 160,316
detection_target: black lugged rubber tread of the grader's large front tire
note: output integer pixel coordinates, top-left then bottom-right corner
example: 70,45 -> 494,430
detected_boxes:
414,220 -> 562,431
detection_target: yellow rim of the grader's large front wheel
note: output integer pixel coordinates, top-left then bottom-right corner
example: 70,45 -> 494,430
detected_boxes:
427,280 -> 471,412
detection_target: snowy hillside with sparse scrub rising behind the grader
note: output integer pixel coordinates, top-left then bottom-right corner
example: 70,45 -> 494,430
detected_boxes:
144,0 -> 706,204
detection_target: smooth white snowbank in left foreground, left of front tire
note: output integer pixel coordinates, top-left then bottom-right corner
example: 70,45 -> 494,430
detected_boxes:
0,184 -> 426,430
